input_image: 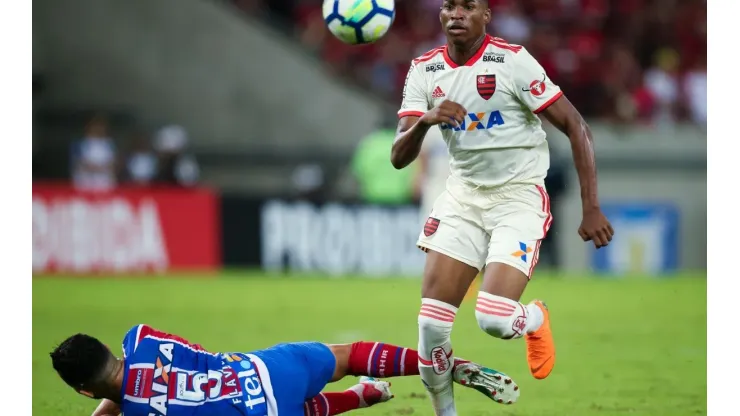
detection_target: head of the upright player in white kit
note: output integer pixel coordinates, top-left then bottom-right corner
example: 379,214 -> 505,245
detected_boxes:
439,0 -> 491,45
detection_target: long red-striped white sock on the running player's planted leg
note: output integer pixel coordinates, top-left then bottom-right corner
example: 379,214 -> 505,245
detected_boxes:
419,298 -> 457,416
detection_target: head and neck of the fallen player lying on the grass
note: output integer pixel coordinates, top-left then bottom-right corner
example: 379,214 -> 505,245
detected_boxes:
49,334 -> 123,398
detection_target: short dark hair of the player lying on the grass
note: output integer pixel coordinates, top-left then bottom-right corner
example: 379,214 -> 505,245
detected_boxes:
49,334 -> 112,389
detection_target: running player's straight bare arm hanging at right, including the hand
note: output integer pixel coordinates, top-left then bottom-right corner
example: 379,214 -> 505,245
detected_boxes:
541,96 -> 614,248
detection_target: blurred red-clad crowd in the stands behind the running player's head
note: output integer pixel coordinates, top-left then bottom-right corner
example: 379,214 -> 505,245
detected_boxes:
231,0 -> 707,125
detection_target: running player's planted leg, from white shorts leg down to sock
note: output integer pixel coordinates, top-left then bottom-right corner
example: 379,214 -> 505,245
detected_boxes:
417,191 -> 488,415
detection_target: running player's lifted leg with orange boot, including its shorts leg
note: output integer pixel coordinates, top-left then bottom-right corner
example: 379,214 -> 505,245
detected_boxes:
475,186 -> 555,379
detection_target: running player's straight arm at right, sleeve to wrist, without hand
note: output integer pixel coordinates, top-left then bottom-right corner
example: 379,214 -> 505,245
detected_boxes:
540,96 -> 599,211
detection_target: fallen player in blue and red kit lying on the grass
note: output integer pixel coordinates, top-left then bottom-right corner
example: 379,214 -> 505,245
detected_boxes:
50,325 -> 519,416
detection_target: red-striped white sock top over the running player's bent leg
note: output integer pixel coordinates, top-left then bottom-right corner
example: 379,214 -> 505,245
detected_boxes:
475,292 -> 523,339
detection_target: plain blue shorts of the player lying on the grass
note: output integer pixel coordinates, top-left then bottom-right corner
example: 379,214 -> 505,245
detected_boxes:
250,342 -> 336,416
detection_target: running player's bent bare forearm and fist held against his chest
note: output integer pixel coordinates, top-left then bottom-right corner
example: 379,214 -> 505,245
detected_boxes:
391,100 -> 467,169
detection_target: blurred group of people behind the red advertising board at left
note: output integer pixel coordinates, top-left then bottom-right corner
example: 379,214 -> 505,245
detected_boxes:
70,115 -> 200,191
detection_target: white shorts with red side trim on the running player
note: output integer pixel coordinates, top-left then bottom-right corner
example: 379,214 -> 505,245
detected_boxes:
416,177 -> 552,278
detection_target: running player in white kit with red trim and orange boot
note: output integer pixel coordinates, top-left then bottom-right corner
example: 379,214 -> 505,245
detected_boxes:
391,0 -> 614,416
